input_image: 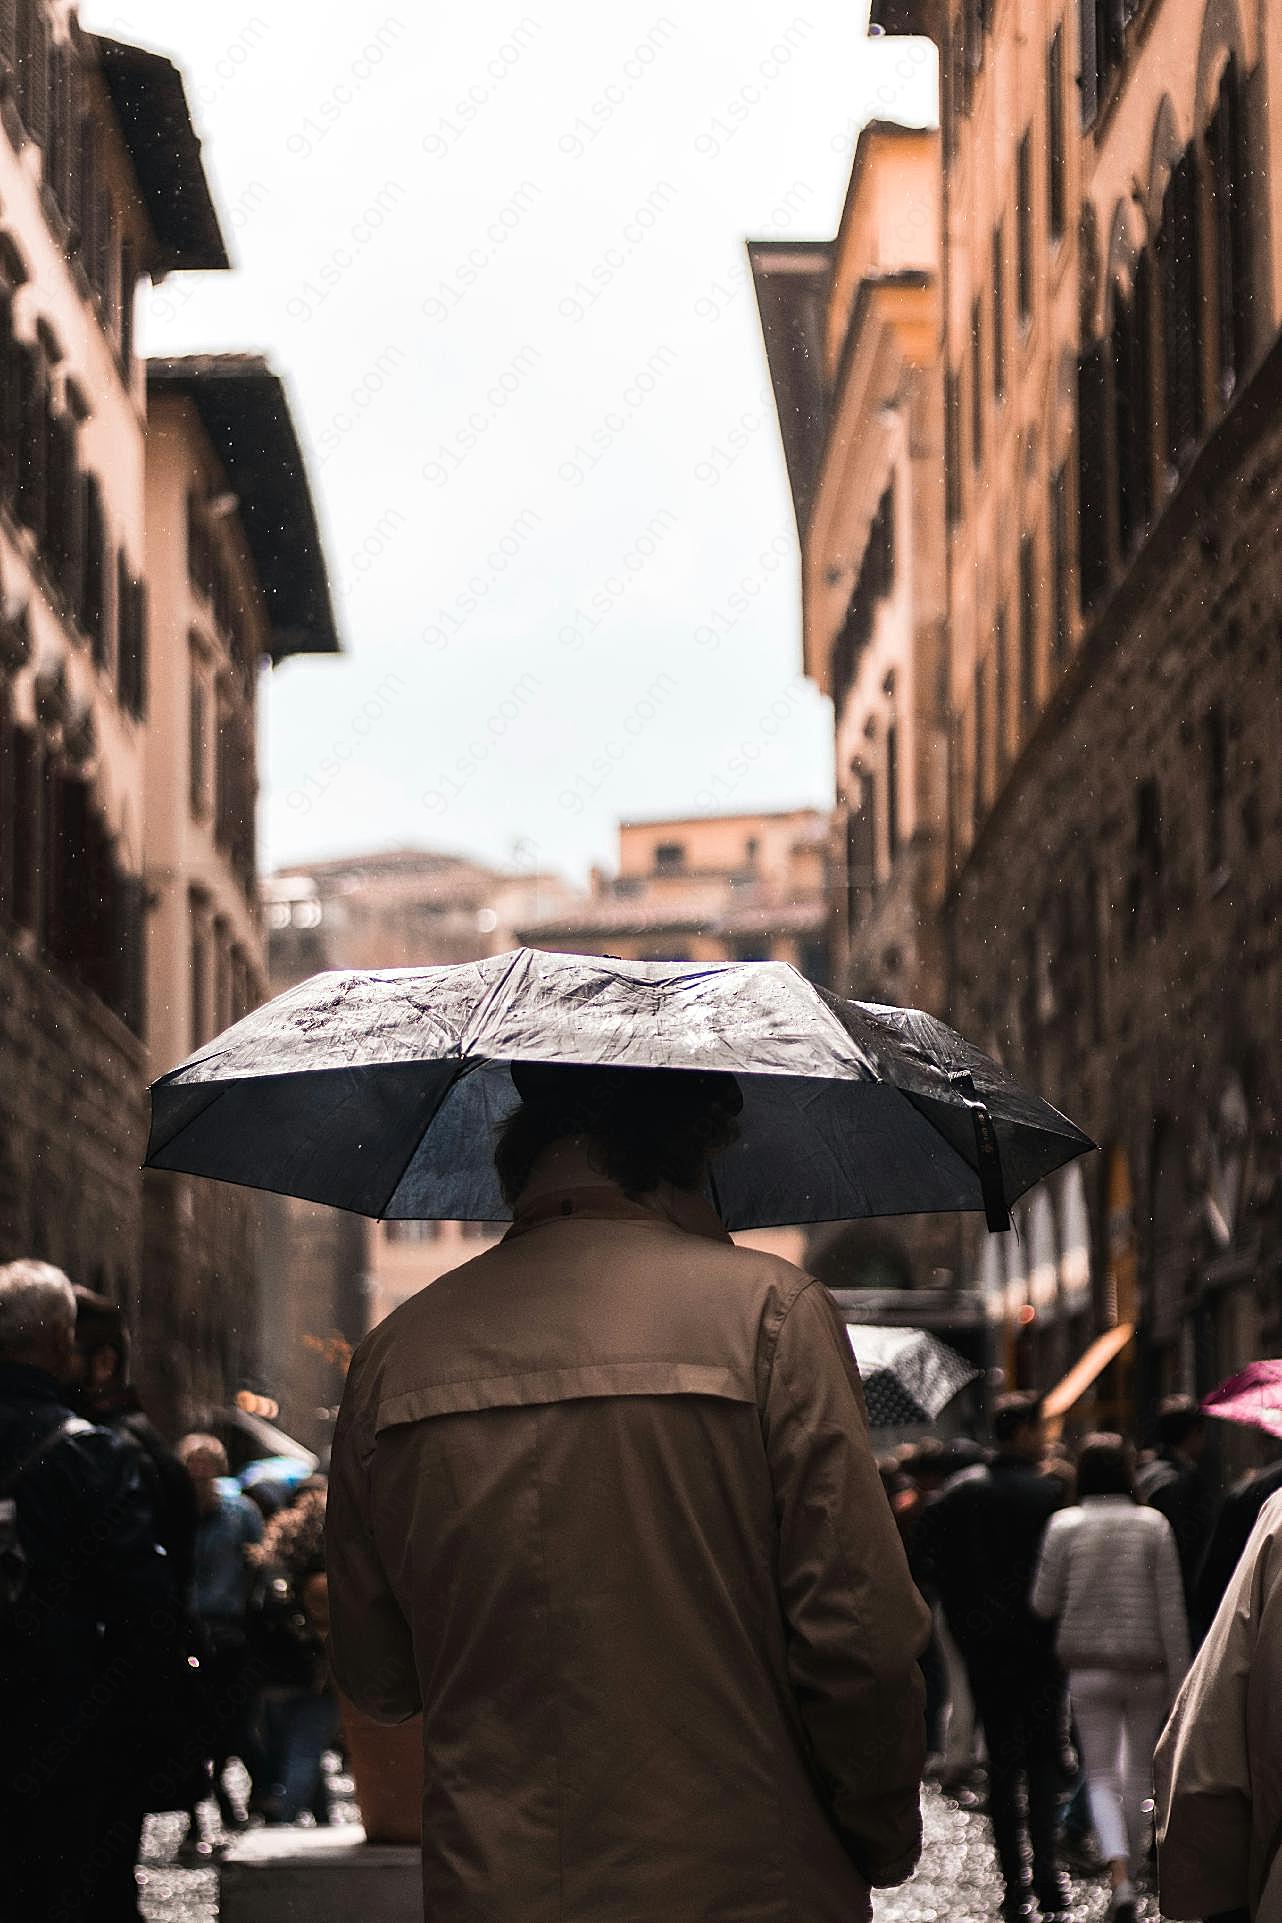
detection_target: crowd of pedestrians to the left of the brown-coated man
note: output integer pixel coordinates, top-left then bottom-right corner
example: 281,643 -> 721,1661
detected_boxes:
0,1261 -> 338,1923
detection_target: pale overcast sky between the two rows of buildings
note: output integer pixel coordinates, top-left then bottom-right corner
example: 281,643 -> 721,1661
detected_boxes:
81,0 -> 934,871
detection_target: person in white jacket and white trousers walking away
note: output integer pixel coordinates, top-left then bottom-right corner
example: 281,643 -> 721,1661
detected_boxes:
1032,1435 -> 1188,1923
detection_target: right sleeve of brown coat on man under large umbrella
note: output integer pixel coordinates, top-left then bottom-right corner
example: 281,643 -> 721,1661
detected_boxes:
763,1283 -> 930,1886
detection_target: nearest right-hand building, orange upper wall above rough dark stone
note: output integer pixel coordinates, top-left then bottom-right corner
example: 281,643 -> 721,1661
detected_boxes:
853,0 -> 1282,1415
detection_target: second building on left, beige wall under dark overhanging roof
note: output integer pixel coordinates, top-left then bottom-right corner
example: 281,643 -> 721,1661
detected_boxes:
138,354 -> 338,1438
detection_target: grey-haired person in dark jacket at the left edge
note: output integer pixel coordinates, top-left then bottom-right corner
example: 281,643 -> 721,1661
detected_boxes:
0,1261 -> 169,1923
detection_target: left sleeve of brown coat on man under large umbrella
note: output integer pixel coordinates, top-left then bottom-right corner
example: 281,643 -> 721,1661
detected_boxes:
325,1354 -> 423,1723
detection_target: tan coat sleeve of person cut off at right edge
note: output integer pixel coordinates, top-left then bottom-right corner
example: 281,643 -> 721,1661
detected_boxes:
1155,1517 -> 1276,1917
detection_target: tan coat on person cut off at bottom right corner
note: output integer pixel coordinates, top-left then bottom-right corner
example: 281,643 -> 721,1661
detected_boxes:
1157,1496 -> 1282,1923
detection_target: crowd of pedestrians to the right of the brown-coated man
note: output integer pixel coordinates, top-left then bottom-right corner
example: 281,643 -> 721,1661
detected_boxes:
880,1394 -> 1282,1923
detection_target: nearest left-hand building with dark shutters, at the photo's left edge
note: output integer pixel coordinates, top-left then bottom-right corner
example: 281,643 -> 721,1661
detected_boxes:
0,15 -> 227,1311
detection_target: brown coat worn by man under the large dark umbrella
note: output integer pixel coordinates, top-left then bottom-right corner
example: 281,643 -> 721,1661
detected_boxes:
329,1188 -> 928,1923
